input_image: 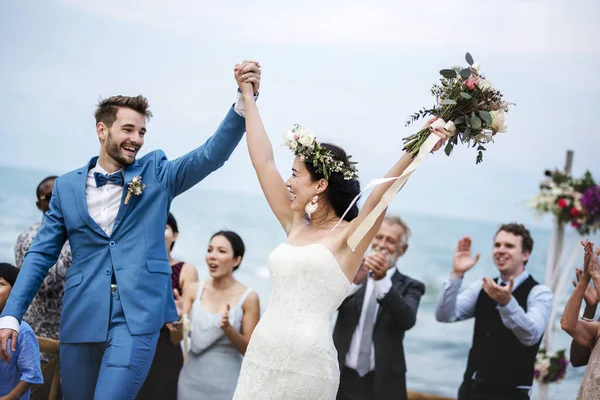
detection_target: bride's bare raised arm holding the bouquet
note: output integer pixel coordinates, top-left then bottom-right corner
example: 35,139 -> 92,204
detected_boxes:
345,118 -> 450,255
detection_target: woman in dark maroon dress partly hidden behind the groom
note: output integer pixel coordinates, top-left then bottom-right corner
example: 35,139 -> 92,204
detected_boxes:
137,213 -> 198,400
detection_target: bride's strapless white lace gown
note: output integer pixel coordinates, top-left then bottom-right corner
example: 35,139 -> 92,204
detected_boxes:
232,243 -> 350,400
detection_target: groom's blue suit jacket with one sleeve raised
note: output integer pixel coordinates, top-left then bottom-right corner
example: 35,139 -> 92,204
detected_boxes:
2,108 -> 245,343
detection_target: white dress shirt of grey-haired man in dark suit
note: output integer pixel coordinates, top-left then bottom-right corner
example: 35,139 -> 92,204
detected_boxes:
346,267 -> 397,371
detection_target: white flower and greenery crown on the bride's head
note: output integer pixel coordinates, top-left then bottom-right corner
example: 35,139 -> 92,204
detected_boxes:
283,124 -> 358,180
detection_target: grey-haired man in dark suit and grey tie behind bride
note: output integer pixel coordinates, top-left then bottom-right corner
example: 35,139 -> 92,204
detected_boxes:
333,216 -> 425,400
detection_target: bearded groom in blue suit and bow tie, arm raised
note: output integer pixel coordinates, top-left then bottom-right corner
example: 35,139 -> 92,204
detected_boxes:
0,62 -> 260,400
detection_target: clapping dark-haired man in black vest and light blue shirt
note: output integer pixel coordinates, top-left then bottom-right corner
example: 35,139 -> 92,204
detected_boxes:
436,224 -> 552,400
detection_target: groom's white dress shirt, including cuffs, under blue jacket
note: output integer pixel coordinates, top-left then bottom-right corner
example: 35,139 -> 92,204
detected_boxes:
0,92 -> 248,333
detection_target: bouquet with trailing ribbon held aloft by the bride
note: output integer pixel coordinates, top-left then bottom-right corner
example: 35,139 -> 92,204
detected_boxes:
403,53 -> 512,164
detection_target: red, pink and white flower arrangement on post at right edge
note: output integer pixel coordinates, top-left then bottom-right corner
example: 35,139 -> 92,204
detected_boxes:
529,170 -> 600,235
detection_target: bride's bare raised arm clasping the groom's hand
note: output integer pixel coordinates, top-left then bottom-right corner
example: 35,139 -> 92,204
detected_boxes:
234,63 -> 293,233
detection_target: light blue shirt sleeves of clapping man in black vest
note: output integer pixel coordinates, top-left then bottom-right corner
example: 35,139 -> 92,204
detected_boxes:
435,271 -> 552,346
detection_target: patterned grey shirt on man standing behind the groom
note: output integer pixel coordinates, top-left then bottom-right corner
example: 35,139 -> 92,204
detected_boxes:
15,222 -> 71,361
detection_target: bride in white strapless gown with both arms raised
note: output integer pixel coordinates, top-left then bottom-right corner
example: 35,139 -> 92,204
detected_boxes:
233,62 -> 449,400
